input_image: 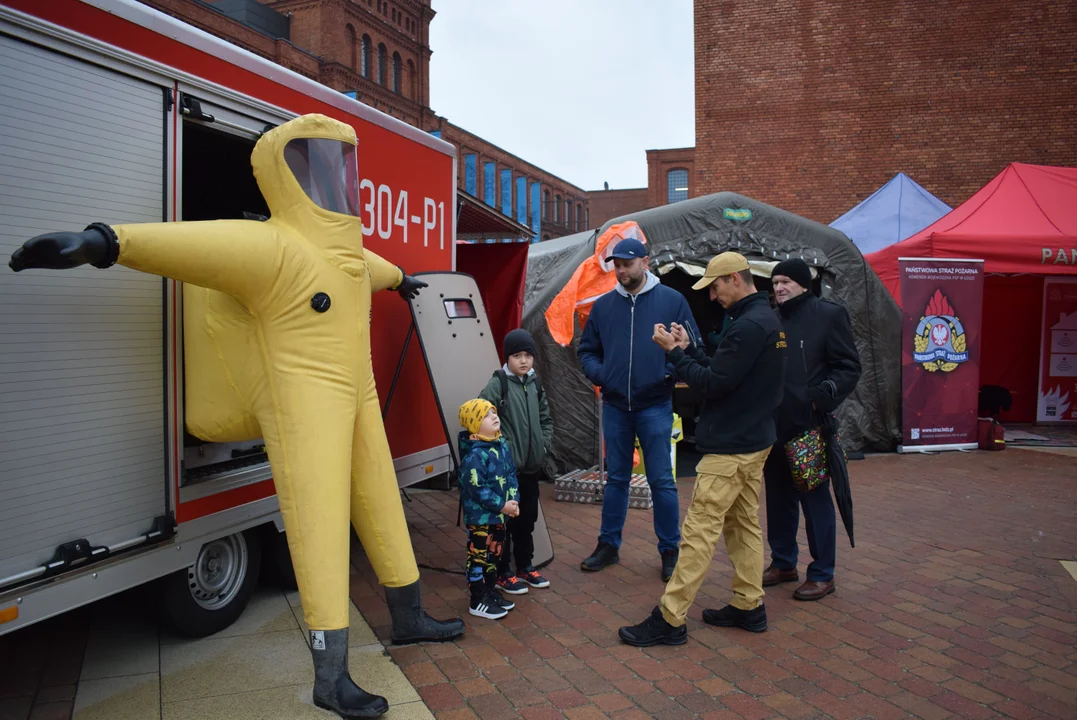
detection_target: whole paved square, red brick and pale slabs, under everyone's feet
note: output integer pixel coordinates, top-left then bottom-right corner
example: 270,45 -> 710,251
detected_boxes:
0,449 -> 1077,720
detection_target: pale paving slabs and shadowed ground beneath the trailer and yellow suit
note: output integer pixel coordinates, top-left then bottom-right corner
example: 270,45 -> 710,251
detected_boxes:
0,588 -> 432,720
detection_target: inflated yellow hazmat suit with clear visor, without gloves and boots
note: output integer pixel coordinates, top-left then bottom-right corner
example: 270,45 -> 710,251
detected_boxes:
113,115 -> 419,630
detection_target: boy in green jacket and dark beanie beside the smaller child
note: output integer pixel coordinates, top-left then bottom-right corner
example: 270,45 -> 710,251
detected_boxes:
479,328 -> 554,595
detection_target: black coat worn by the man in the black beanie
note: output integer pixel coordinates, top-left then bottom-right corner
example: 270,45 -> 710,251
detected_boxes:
774,293 -> 861,444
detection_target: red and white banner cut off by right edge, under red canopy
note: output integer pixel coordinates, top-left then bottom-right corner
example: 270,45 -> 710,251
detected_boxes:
1036,278 -> 1077,423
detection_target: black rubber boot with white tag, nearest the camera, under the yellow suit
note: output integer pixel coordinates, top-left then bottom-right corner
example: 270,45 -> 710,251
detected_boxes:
310,629 -> 389,720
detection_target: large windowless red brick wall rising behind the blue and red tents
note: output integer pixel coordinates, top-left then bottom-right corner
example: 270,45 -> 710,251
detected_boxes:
694,0 -> 1077,223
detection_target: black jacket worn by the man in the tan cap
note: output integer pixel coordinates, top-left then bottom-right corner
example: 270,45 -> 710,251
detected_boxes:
669,293 -> 786,455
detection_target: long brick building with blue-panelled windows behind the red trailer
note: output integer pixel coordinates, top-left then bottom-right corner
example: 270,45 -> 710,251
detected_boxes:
141,0 -> 588,239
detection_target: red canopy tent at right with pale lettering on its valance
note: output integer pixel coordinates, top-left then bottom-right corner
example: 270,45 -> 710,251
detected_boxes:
865,163 -> 1077,422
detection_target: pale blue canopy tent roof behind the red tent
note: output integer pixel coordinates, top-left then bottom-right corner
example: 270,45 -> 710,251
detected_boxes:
830,172 -> 952,255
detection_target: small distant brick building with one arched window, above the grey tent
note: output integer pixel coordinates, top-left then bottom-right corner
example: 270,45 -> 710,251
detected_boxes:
587,147 -> 699,227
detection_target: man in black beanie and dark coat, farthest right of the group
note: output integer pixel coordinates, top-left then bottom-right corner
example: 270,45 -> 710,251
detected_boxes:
763,259 -> 861,601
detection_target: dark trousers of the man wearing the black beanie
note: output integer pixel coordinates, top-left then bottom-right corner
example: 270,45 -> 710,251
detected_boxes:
763,446 -> 838,582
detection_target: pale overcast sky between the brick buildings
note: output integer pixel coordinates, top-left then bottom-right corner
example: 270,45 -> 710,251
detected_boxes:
430,0 -> 696,190
